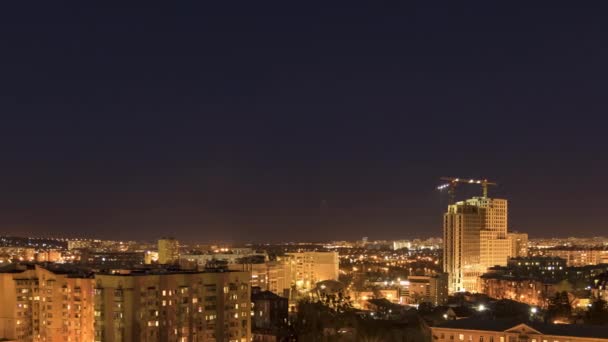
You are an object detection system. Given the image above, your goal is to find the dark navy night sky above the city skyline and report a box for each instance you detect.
[0,1,608,242]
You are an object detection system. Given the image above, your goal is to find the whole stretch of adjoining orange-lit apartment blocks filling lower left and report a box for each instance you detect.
[0,264,251,342]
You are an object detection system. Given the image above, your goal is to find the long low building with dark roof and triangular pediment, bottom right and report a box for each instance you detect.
[431,318,608,342]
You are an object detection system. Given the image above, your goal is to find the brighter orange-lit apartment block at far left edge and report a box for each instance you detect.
[0,264,96,342]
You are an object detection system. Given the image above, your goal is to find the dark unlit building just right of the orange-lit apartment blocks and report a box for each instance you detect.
[251,287,289,342]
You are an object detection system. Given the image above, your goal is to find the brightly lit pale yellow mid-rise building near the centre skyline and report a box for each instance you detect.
[287,252,339,289]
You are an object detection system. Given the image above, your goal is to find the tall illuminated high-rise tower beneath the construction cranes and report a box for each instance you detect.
[443,197,511,292]
